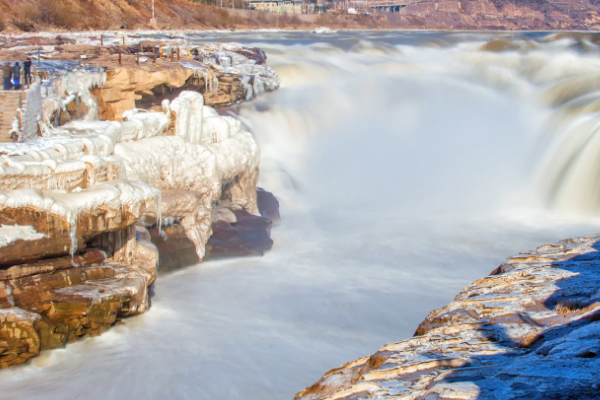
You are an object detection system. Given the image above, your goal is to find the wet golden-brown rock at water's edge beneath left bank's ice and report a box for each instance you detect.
[0,227,158,368]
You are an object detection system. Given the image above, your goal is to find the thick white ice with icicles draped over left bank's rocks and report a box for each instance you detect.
[0,92,259,258]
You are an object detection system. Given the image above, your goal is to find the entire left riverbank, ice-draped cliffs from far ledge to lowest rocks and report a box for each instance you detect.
[0,42,280,368]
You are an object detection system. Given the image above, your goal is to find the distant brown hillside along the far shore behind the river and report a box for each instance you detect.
[0,0,600,32]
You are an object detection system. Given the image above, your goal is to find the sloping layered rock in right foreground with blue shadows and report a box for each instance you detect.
[296,236,600,400]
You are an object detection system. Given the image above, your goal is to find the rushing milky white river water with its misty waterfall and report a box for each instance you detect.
[0,33,600,400]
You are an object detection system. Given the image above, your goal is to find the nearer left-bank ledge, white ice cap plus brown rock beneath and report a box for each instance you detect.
[0,78,276,368]
